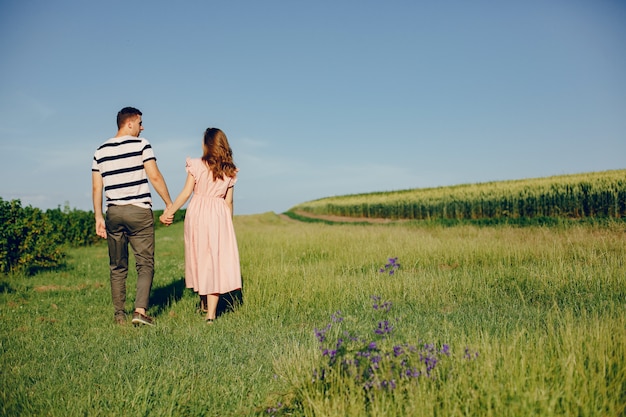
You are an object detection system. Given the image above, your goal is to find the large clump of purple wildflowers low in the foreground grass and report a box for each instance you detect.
[313,296,450,390]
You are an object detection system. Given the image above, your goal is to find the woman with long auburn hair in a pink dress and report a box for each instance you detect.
[160,128,241,324]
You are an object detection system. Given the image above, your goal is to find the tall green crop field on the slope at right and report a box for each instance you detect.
[292,170,626,220]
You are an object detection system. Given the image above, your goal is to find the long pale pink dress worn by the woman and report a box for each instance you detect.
[185,158,241,295]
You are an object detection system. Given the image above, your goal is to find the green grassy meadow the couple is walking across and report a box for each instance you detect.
[0,213,626,416]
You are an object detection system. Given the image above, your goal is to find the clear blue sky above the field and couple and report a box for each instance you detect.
[0,0,626,214]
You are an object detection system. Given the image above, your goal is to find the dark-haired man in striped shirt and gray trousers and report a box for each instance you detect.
[91,107,172,325]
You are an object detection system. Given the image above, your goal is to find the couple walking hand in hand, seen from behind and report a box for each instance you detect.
[91,107,241,325]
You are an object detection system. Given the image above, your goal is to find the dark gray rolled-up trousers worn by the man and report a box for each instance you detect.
[106,205,154,316]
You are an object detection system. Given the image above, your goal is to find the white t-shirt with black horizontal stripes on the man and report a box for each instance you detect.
[91,136,156,208]
